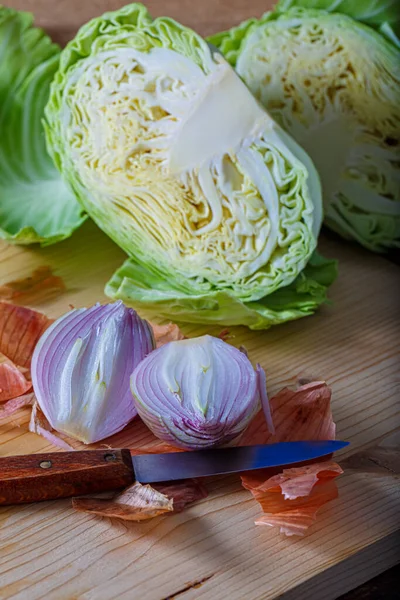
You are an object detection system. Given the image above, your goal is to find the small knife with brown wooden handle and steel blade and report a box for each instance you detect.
[0,441,348,505]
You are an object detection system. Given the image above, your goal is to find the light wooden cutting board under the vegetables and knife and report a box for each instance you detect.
[0,0,400,600]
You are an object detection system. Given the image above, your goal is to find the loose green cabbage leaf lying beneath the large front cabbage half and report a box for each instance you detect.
[106,252,337,329]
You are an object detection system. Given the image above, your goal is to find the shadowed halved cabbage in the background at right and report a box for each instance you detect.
[210,9,400,251]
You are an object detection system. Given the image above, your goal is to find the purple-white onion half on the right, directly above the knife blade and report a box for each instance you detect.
[131,335,268,450]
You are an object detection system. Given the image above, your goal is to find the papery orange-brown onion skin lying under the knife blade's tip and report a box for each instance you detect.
[241,381,343,535]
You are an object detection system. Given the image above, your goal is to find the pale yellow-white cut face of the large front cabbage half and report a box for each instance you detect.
[61,47,320,299]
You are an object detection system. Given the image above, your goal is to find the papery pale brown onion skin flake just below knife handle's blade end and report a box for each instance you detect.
[72,481,174,521]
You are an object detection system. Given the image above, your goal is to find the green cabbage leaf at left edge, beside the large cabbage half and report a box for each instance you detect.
[0,6,84,245]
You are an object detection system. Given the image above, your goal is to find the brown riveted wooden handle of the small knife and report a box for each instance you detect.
[0,450,135,505]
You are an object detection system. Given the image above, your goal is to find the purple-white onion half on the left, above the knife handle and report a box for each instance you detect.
[32,302,155,444]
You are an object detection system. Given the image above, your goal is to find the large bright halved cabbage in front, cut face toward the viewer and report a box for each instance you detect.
[46,4,334,323]
